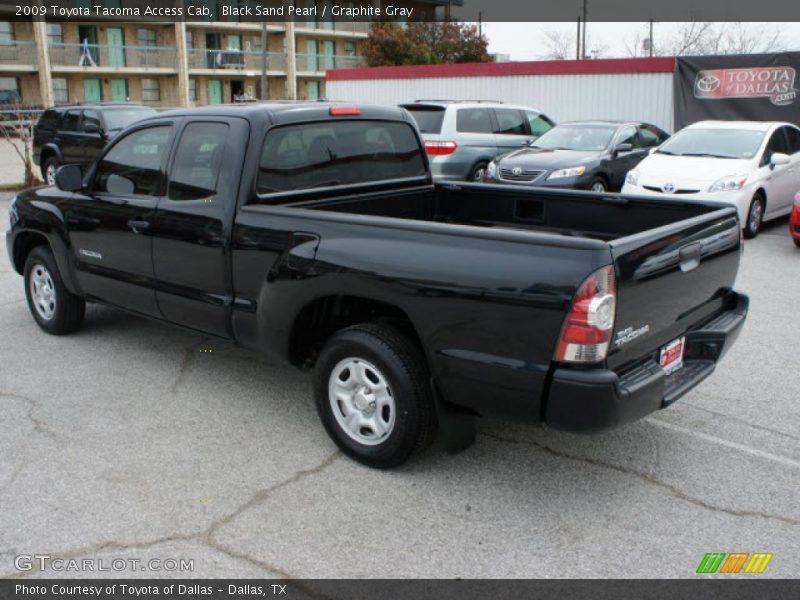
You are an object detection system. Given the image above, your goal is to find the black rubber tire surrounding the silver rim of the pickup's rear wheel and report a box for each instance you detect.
[314,323,436,469]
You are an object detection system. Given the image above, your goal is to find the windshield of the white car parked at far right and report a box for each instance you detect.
[657,128,764,158]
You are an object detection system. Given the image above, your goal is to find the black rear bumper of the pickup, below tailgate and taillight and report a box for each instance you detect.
[545,292,749,433]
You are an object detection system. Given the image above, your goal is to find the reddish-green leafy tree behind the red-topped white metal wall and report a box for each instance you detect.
[363,21,492,67]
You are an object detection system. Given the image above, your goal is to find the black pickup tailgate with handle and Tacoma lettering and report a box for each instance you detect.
[608,207,742,370]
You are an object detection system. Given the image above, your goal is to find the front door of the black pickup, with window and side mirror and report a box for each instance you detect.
[65,122,173,316]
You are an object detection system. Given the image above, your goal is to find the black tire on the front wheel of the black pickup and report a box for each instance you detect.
[24,246,86,335]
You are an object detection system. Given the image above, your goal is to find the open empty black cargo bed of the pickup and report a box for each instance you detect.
[292,183,719,241]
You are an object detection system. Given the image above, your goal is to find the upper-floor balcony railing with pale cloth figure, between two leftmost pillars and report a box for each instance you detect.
[50,44,178,69]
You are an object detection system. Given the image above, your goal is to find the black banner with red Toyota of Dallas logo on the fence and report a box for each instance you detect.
[674,52,800,131]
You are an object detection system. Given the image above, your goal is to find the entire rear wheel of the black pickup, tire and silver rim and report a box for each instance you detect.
[314,324,436,469]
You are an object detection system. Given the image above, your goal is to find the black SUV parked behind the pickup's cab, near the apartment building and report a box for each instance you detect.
[33,102,156,185]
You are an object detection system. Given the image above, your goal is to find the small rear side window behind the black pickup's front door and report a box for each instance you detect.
[167,123,229,200]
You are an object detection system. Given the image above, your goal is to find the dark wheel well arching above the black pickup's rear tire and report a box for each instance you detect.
[289,295,422,366]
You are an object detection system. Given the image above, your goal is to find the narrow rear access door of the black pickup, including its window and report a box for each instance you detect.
[153,117,249,337]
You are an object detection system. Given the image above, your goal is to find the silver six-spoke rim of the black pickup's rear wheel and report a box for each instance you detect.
[328,358,396,446]
